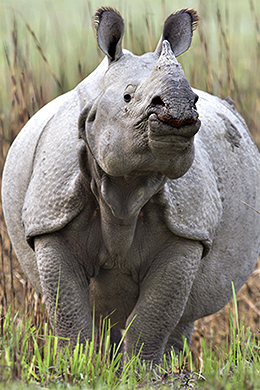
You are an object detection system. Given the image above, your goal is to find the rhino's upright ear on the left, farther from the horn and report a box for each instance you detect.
[94,7,124,61]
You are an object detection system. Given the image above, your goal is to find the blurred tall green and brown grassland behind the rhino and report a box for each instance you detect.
[0,0,260,372]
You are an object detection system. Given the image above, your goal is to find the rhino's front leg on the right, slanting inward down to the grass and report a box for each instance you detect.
[126,237,203,365]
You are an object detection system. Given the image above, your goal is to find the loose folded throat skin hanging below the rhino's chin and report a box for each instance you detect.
[96,173,164,256]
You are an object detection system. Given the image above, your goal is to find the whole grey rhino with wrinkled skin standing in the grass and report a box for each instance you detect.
[2,8,260,364]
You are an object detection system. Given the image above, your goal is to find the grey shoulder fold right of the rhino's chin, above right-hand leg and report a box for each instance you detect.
[162,137,223,255]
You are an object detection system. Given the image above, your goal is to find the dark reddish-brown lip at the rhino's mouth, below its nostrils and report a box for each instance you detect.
[148,108,201,138]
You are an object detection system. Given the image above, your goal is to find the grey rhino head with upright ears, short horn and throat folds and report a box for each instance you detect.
[79,8,200,254]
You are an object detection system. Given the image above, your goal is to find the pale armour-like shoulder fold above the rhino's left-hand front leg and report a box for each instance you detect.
[22,94,84,243]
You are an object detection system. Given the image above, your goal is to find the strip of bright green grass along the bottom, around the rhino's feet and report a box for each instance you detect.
[0,288,260,390]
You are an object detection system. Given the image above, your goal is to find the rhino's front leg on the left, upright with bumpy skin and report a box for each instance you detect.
[35,233,92,347]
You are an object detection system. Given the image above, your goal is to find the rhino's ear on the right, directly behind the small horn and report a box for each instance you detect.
[155,9,200,57]
